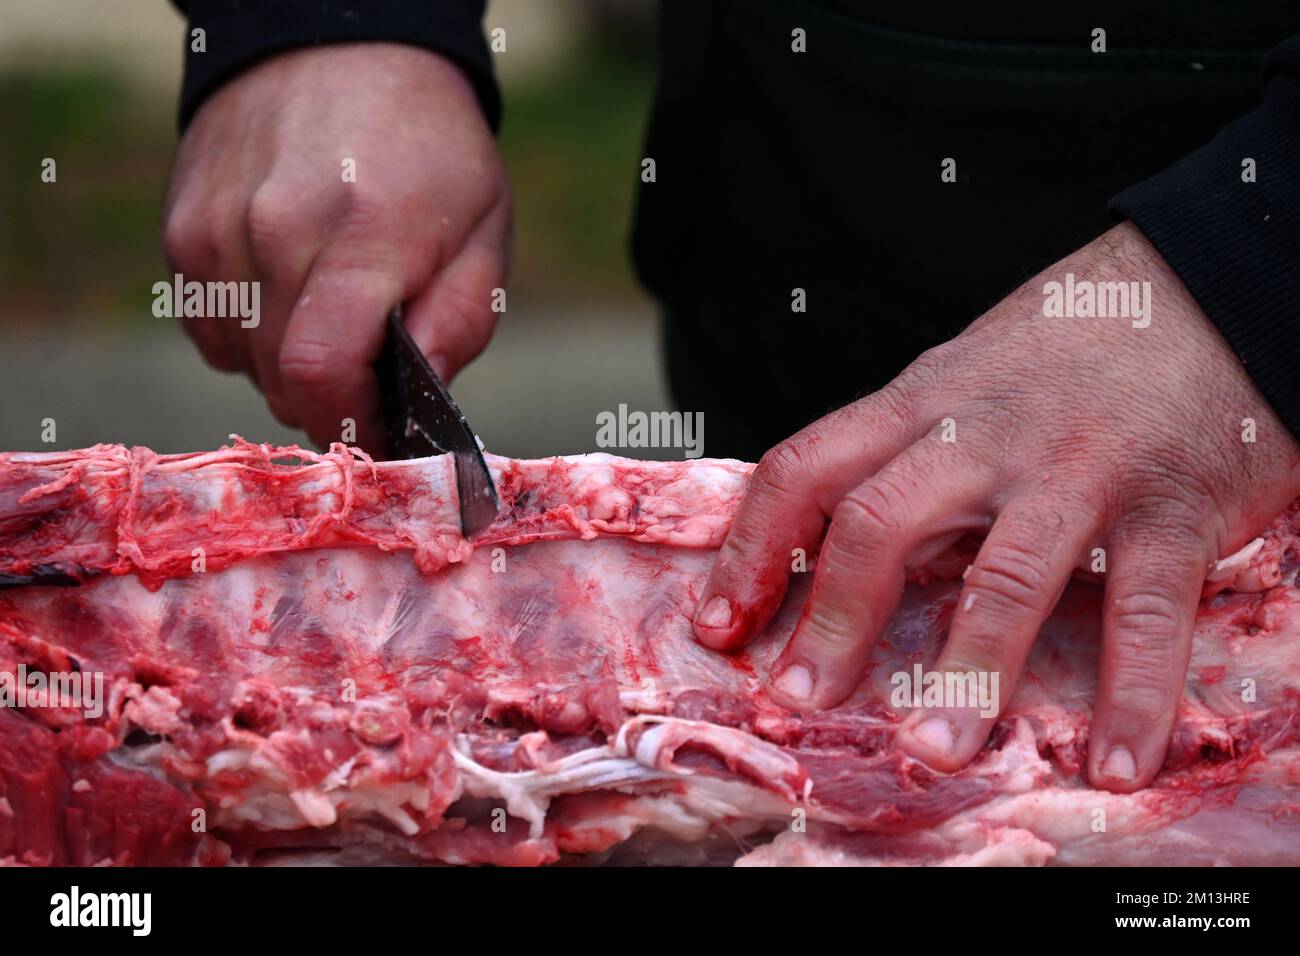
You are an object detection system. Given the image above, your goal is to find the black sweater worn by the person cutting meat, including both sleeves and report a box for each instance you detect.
[178,0,1300,458]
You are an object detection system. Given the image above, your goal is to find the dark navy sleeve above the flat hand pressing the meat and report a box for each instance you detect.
[1110,36,1300,438]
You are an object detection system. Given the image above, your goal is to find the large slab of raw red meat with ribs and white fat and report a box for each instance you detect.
[0,441,1300,865]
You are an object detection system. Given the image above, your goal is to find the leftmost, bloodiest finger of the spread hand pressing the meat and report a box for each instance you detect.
[694,389,923,650]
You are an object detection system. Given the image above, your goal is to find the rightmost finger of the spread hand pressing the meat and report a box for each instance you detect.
[1088,522,1209,793]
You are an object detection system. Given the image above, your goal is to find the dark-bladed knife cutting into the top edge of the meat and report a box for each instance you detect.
[374,307,498,537]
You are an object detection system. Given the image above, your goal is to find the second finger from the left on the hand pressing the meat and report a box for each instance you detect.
[770,441,993,710]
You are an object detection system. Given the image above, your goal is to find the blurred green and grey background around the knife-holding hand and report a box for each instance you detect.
[0,0,680,457]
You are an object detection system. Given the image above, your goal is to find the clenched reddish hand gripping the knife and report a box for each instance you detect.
[164,43,510,450]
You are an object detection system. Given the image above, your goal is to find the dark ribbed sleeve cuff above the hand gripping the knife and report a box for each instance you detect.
[174,0,501,131]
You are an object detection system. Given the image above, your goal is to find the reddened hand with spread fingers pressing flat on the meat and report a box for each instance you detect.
[696,224,1300,792]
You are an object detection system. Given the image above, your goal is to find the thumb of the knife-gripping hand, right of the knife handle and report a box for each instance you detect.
[406,193,510,382]
